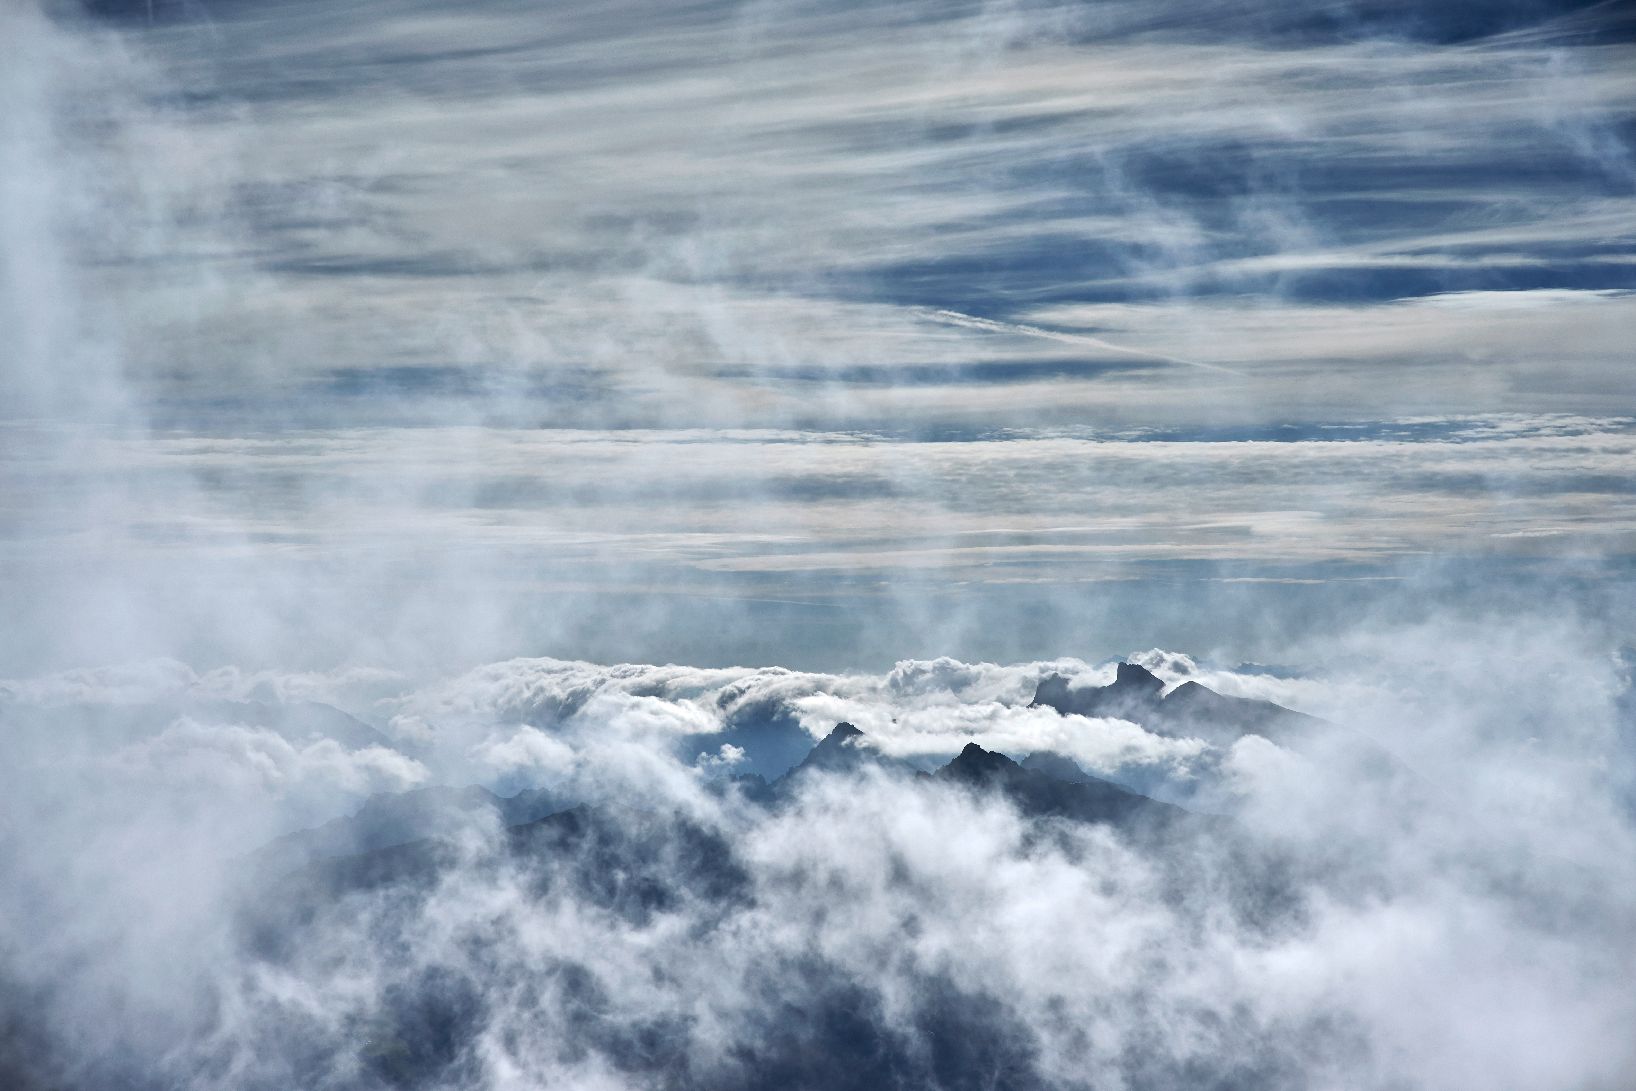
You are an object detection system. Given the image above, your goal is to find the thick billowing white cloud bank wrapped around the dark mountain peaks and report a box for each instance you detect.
[7,623,1636,1091]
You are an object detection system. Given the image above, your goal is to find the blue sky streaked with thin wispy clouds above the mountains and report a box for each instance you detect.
[0,0,1636,669]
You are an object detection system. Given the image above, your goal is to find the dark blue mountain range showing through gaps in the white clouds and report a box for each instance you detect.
[227,669,1328,1091]
